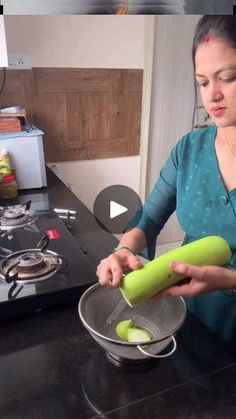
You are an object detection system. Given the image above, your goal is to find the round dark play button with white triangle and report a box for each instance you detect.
[93,185,142,234]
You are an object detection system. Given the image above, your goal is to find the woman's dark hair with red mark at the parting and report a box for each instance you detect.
[192,15,236,68]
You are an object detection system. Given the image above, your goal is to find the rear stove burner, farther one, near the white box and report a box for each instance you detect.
[0,201,37,230]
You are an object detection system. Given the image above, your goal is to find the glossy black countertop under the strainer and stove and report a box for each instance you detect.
[0,169,236,419]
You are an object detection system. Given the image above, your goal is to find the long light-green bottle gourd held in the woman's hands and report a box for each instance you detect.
[119,236,232,306]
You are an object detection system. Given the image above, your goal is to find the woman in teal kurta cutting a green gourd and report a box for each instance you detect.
[97,16,236,342]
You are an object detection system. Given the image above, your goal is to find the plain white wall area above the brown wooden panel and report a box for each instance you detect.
[5,15,145,68]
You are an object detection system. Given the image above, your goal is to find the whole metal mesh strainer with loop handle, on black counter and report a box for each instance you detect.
[78,284,186,362]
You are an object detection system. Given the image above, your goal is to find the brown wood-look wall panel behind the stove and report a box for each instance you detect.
[0,68,143,162]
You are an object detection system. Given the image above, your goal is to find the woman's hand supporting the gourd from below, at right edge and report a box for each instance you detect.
[155,262,236,298]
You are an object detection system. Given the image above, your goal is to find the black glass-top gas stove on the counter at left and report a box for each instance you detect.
[0,194,96,319]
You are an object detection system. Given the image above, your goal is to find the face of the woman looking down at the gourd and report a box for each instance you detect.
[195,36,236,127]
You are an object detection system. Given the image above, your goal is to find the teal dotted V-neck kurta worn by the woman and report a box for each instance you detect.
[136,125,236,343]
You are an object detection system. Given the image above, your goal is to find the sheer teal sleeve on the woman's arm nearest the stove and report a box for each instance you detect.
[132,144,179,259]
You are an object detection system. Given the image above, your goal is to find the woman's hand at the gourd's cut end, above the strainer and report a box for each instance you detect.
[96,250,143,288]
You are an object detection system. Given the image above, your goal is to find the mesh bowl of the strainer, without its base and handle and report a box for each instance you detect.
[79,284,186,351]
